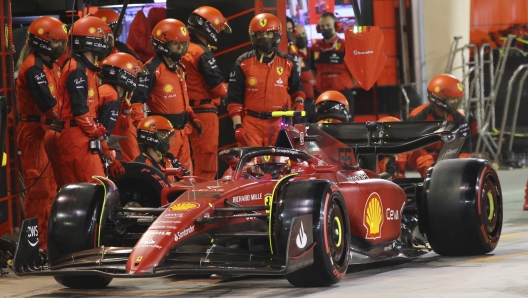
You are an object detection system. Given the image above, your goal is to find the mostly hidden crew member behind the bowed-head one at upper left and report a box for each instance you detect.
[93,9,139,161]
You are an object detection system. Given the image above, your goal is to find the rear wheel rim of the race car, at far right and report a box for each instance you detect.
[480,176,502,239]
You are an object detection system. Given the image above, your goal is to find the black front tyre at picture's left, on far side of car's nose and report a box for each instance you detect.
[48,183,112,289]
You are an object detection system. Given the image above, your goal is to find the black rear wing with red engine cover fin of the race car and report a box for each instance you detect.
[276,121,465,170]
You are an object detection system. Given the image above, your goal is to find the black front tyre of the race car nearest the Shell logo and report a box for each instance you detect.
[272,180,350,287]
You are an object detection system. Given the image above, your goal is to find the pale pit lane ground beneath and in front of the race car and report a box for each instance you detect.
[0,169,528,298]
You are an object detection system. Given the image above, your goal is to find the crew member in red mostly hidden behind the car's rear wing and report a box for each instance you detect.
[395,74,471,178]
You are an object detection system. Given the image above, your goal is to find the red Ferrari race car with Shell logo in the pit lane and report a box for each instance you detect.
[13,122,503,288]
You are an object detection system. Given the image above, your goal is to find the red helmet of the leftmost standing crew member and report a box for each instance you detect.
[27,16,68,60]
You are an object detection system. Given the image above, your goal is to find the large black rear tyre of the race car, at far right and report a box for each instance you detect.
[420,158,503,256]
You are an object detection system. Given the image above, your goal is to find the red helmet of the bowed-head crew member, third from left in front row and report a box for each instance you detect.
[100,52,144,92]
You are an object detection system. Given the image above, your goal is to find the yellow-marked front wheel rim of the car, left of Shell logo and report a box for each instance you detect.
[326,198,347,266]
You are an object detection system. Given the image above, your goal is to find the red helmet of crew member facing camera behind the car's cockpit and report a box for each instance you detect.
[249,13,282,54]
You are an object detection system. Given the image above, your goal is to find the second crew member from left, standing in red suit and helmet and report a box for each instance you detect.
[57,16,113,184]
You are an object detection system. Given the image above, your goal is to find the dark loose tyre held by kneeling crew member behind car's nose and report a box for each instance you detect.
[110,162,166,208]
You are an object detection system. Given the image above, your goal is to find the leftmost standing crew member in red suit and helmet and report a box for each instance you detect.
[16,16,68,250]
